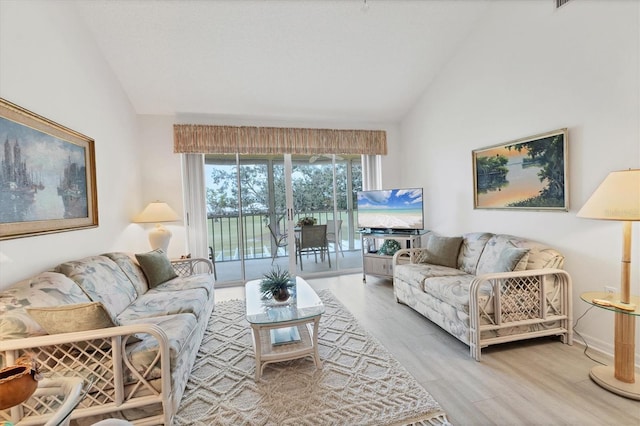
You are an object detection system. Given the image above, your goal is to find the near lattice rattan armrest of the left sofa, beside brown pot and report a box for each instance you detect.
[0,324,174,424]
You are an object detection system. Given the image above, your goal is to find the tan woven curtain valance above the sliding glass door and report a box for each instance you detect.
[173,124,387,155]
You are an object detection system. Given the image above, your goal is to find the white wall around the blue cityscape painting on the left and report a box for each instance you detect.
[0,0,146,288]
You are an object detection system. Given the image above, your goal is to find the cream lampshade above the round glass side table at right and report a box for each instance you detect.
[577,169,640,221]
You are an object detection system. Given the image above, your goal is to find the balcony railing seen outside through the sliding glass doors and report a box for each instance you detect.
[207,210,357,262]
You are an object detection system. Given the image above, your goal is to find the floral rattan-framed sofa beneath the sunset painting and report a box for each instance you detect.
[393,232,573,361]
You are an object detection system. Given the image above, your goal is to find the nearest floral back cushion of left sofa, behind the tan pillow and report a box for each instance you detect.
[0,272,91,341]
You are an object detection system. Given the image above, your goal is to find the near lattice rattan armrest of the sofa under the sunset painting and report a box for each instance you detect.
[469,268,573,361]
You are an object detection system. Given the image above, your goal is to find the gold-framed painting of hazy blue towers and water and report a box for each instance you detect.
[0,98,98,240]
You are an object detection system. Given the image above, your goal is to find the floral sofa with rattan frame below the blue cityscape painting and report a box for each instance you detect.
[0,250,214,425]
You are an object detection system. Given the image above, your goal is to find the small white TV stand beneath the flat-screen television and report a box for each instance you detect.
[360,229,426,283]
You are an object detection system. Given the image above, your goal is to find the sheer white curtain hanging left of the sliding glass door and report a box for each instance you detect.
[182,154,209,258]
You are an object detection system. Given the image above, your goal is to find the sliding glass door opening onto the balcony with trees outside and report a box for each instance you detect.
[205,155,362,282]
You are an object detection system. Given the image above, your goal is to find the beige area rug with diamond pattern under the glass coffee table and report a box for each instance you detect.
[175,290,448,425]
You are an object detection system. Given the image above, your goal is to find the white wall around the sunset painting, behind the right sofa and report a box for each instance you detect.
[401,0,640,359]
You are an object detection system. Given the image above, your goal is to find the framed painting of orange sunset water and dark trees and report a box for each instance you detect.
[473,129,569,211]
